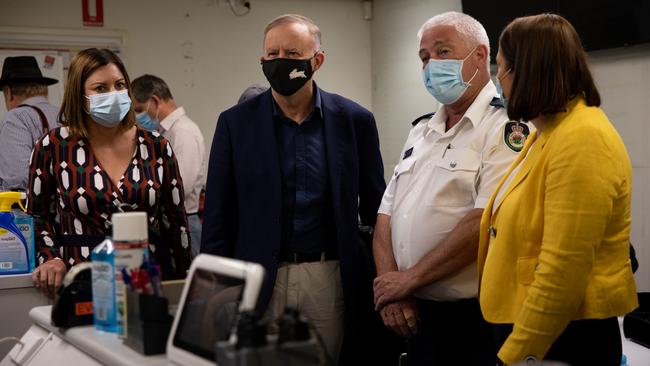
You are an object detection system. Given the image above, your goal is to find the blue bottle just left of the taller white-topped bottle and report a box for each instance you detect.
[91,238,117,333]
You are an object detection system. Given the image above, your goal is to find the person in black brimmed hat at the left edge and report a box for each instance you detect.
[0,56,59,191]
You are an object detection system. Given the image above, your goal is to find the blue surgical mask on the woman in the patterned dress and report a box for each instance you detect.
[86,90,131,128]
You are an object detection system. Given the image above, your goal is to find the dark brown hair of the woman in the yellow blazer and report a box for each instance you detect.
[499,14,600,121]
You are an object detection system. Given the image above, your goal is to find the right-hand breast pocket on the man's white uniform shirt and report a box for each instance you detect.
[430,148,480,206]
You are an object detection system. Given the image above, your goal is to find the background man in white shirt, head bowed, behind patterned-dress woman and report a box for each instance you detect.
[131,74,205,257]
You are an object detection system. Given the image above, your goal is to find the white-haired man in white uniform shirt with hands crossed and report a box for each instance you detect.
[373,12,528,366]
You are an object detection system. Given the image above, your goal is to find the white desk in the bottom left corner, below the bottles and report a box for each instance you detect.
[0,306,171,366]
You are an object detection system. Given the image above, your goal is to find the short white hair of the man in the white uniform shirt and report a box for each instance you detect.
[418,11,490,68]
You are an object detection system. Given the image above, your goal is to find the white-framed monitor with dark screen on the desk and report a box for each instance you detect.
[167,254,264,366]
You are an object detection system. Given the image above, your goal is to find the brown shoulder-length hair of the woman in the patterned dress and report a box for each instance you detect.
[59,48,135,138]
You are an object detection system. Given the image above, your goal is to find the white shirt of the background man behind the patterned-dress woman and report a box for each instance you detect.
[160,107,205,214]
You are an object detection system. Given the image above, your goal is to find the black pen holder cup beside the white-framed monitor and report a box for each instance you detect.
[124,290,173,355]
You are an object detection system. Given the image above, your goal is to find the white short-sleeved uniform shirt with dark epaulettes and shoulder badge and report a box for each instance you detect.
[379,81,517,301]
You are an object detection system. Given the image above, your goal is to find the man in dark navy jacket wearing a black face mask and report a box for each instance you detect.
[201,15,385,365]
